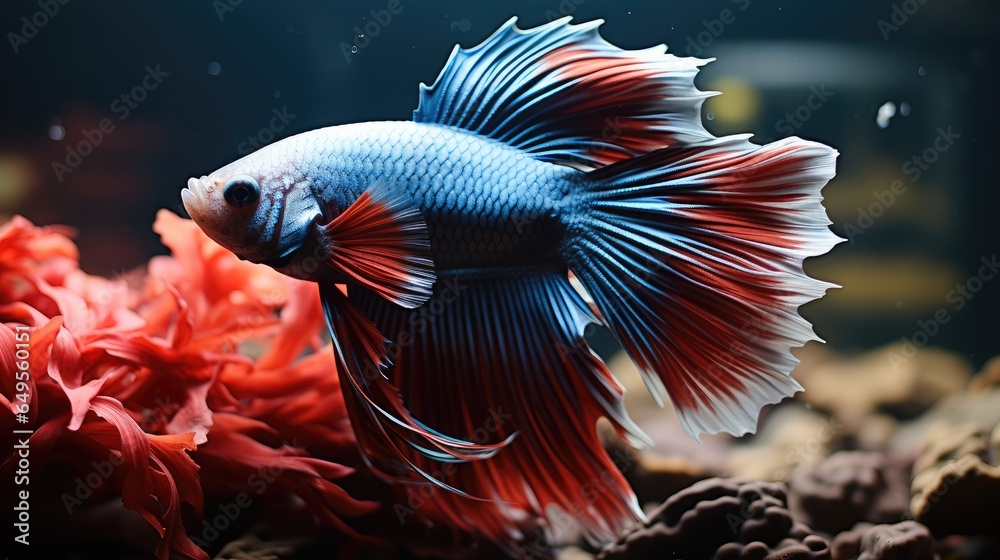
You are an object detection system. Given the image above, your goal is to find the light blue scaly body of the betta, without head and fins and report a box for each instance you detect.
[292,122,580,269]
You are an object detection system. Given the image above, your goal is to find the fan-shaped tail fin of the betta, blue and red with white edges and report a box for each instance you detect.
[566,136,841,439]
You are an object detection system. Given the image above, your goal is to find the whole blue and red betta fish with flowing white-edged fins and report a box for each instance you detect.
[181,18,841,543]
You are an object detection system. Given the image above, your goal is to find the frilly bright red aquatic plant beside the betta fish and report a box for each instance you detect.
[0,211,376,560]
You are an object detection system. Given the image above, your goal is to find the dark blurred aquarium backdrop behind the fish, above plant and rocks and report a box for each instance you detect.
[0,0,1000,367]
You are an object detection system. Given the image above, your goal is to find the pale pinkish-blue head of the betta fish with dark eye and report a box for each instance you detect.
[181,158,323,279]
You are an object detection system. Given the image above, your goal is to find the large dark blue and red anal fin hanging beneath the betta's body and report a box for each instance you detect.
[351,265,647,543]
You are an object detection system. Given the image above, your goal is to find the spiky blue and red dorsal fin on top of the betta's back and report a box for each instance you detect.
[413,17,714,168]
